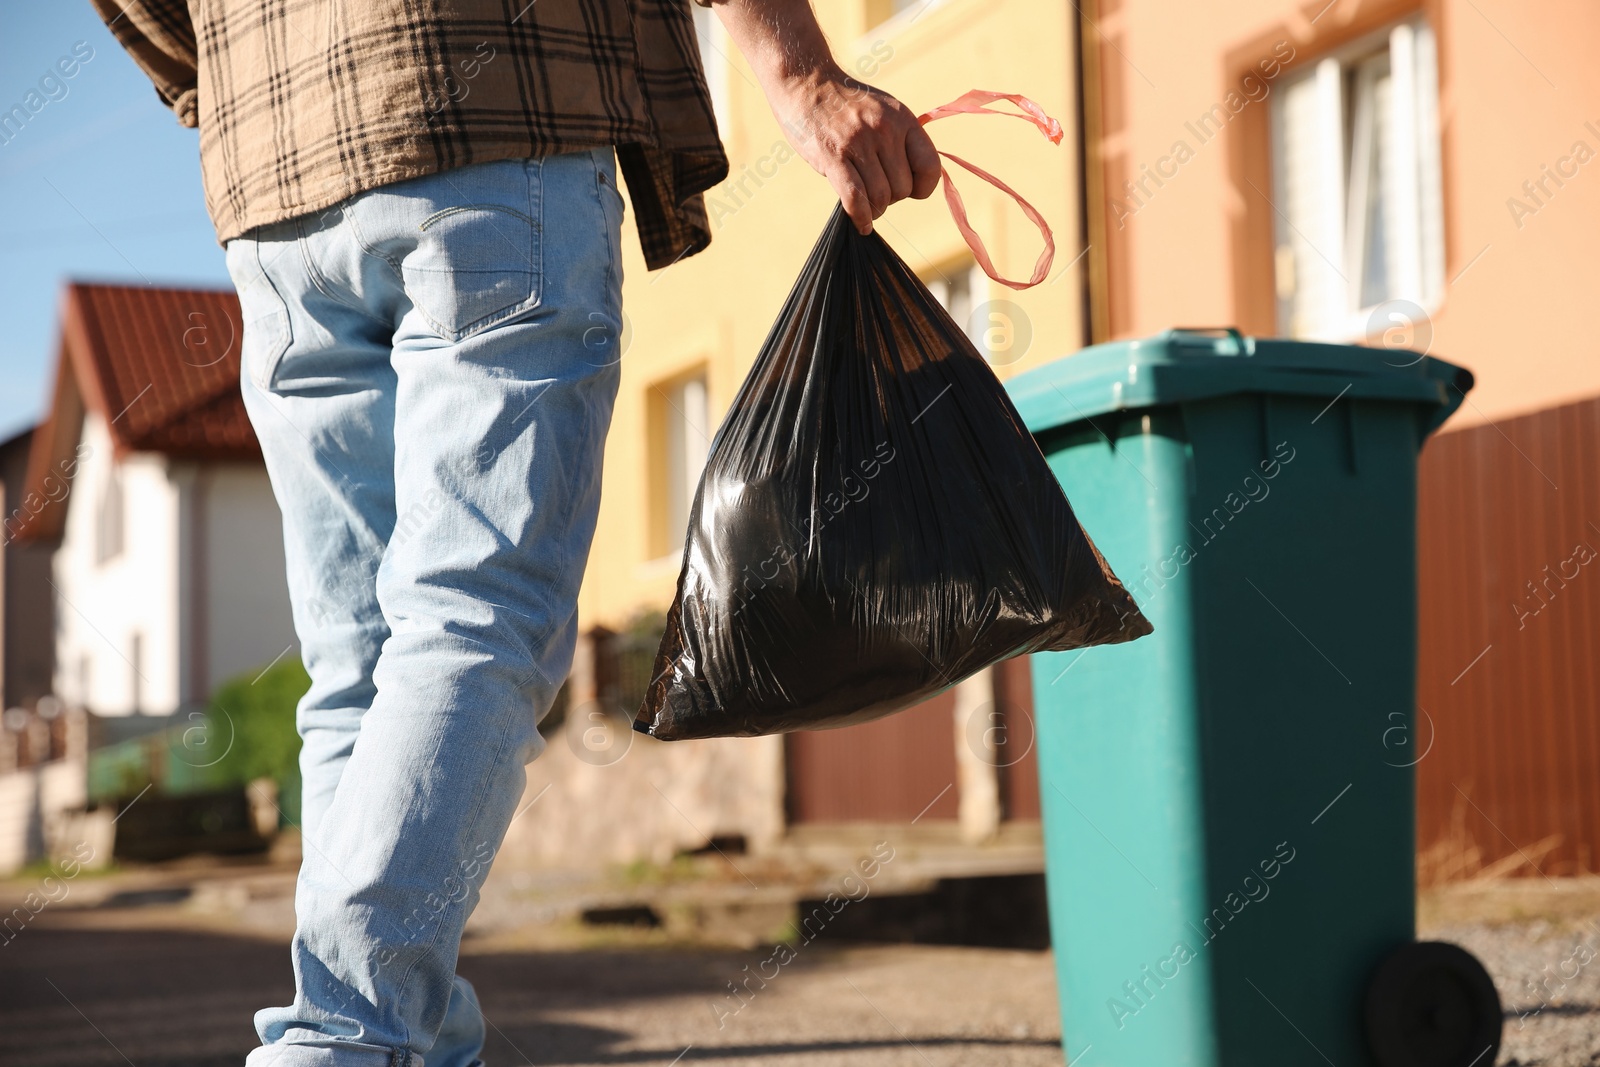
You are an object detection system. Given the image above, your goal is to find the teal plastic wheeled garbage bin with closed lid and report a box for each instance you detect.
[1008,330,1501,1067]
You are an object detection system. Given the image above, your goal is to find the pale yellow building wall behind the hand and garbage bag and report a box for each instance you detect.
[579,0,1082,627]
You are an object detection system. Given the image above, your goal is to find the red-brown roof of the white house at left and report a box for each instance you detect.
[6,283,261,539]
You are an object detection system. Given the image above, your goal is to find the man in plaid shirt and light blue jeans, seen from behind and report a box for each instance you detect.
[94,0,939,1067]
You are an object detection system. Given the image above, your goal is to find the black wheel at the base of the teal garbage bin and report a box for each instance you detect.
[1365,941,1502,1067]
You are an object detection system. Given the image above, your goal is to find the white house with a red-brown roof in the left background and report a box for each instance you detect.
[6,283,294,717]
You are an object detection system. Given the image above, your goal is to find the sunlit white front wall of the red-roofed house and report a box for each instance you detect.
[53,413,182,715]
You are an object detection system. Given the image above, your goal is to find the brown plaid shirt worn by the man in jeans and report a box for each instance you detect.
[93,0,728,269]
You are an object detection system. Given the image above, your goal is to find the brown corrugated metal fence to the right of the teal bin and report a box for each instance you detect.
[1397,391,1600,881]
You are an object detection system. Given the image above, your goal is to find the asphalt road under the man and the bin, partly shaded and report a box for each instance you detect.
[0,872,1600,1067]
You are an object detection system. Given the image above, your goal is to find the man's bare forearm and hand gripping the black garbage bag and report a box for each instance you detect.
[710,0,939,234]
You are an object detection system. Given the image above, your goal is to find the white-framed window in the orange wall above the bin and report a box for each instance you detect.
[1272,19,1445,339]
